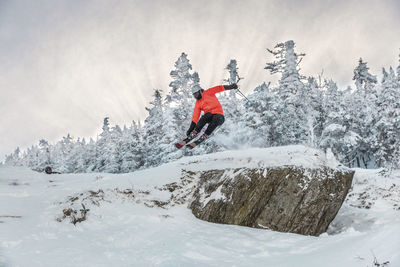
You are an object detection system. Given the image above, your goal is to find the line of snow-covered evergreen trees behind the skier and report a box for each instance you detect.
[5,40,400,173]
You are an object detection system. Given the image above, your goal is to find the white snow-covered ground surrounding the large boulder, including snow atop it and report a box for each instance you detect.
[0,146,400,267]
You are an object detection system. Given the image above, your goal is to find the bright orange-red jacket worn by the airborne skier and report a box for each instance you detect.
[192,85,225,123]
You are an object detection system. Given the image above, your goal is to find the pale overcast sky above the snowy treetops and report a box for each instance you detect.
[0,0,400,161]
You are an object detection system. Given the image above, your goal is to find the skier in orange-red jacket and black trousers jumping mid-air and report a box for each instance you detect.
[175,83,238,149]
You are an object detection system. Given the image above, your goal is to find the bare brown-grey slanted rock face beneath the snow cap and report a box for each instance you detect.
[190,166,354,236]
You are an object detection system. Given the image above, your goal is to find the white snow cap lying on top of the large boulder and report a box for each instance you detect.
[177,145,342,170]
